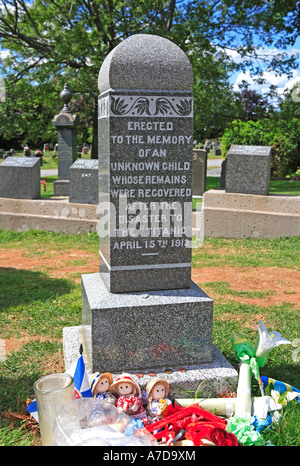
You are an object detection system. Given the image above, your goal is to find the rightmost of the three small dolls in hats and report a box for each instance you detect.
[146,379,172,421]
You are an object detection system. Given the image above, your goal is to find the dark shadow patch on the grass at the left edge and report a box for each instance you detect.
[0,267,74,312]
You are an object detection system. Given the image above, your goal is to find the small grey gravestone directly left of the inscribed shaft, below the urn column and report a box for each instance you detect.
[69,159,99,204]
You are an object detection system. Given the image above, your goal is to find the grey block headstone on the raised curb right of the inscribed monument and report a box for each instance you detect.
[225,145,272,195]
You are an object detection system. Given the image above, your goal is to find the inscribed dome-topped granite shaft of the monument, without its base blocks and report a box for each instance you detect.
[98,34,193,292]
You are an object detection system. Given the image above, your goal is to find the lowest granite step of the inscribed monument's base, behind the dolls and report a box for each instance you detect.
[63,326,238,398]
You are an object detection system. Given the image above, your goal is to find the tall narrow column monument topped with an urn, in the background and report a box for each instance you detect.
[52,84,78,196]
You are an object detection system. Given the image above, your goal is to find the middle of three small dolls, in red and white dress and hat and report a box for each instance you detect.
[110,373,146,419]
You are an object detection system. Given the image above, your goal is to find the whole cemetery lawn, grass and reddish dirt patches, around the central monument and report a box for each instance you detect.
[0,231,300,446]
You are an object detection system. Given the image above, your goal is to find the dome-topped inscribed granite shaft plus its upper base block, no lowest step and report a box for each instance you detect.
[82,34,213,372]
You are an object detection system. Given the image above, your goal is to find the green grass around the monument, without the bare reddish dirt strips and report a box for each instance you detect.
[0,231,300,446]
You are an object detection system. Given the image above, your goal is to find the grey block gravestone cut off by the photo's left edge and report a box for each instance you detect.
[0,157,41,199]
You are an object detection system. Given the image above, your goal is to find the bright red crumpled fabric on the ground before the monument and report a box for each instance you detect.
[146,404,238,446]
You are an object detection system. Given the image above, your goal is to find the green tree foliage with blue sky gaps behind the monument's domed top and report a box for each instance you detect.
[0,0,299,149]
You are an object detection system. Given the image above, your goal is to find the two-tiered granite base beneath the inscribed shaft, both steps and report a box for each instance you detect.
[63,273,238,398]
